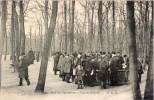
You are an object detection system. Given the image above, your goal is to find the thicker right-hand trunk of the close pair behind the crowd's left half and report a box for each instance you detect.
[70,0,75,53]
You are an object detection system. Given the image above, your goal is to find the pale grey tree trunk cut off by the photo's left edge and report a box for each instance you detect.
[0,0,7,88]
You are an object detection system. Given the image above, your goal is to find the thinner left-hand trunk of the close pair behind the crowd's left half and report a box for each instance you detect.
[64,0,67,52]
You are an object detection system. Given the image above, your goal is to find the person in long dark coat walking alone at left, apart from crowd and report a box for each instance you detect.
[18,53,30,86]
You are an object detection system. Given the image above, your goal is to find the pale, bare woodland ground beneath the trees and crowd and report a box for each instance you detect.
[0,57,146,100]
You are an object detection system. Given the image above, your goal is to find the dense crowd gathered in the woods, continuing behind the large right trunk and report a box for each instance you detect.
[53,52,143,89]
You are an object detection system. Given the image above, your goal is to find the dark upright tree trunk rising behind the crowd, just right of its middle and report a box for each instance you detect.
[98,1,103,50]
